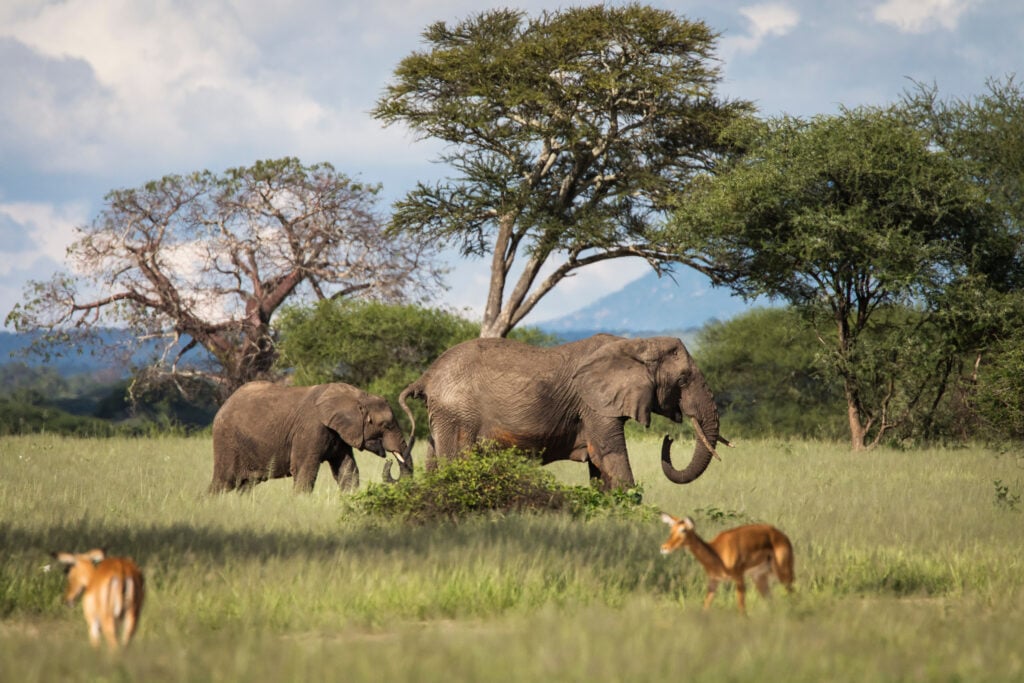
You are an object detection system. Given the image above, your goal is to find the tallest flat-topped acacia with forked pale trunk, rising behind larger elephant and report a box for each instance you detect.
[374,4,752,337]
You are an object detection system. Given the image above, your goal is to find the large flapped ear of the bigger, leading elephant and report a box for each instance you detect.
[572,339,658,427]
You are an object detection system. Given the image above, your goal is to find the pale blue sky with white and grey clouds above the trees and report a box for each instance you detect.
[0,0,1024,331]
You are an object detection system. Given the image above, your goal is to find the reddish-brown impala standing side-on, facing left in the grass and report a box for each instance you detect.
[662,512,793,614]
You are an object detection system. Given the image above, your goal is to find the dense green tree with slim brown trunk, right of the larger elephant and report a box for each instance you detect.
[674,108,1013,451]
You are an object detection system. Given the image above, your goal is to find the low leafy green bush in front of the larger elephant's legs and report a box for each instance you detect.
[348,443,656,522]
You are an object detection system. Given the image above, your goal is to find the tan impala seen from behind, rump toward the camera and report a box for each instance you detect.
[53,549,145,649]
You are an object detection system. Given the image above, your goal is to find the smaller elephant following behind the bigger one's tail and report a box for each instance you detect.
[210,382,413,493]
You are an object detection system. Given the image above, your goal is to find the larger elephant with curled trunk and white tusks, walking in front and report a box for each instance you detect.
[398,334,719,488]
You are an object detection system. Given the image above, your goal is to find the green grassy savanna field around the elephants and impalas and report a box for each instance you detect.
[0,435,1024,683]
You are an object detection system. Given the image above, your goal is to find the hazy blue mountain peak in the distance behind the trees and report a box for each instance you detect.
[537,267,767,339]
